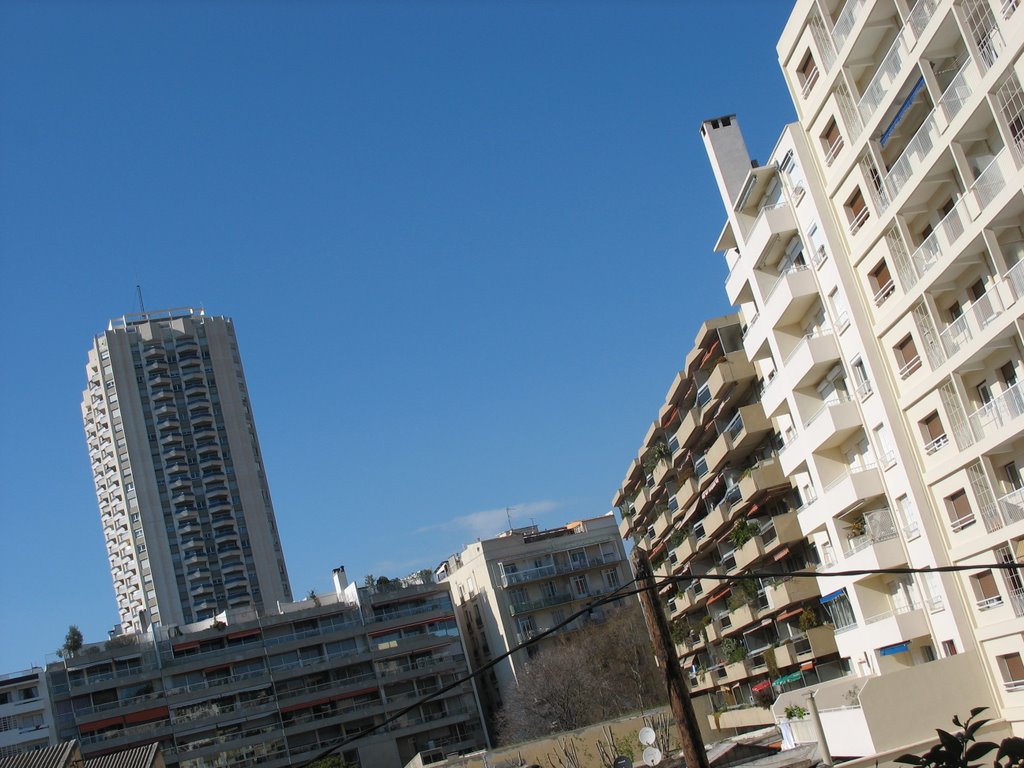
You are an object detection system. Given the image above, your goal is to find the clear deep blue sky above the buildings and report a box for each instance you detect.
[0,0,793,672]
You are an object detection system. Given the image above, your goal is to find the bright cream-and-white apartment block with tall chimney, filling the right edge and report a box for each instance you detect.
[663,0,1024,756]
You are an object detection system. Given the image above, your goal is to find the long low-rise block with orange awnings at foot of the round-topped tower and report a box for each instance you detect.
[46,569,486,768]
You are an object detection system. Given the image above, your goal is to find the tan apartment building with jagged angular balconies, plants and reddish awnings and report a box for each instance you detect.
[612,314,849,738]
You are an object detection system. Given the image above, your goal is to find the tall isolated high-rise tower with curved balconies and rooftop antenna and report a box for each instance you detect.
[82,308,292,631]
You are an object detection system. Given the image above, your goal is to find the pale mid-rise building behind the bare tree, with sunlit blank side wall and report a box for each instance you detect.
[434,512,632,741]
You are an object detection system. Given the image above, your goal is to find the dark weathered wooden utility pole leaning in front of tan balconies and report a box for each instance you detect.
[631,547,710,768]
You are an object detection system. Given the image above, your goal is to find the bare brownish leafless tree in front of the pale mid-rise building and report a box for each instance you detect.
[498,605,667,743]
